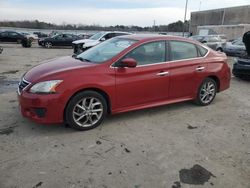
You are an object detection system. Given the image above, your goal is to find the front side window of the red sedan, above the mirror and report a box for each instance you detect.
[123,41,166,65]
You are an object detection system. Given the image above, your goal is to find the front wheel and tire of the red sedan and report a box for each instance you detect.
[65,91,107,131]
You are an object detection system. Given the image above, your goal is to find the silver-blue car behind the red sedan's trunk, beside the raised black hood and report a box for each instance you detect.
[223,38,246,57]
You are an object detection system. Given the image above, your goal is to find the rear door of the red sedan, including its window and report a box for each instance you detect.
[169,41,208,99]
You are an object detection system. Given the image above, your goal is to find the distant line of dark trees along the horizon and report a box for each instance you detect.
[0,20,189,32]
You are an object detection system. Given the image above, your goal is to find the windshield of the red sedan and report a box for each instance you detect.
[75,38,136,64]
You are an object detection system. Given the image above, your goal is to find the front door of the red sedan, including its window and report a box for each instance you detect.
[116,41,169,109]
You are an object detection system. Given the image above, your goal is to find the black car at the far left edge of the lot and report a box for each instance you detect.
[0,31,27,43]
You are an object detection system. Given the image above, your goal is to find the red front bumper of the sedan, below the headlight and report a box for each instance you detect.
[18,91,65,124]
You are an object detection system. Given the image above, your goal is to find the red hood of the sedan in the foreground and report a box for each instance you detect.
[24,56,95,83]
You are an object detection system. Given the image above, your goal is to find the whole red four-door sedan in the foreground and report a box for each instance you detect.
[18,35,231,130]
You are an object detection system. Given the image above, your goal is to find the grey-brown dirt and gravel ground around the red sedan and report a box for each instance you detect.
[0,44,250,188]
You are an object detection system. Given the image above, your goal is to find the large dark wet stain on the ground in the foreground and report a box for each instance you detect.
[179,164,216,185]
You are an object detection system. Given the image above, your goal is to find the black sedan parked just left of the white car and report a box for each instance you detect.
[38,34,79,48]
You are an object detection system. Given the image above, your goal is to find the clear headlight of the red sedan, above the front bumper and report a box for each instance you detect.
[30,80,63,93]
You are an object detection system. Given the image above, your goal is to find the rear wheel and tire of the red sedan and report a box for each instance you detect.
[195,78,218,106]
